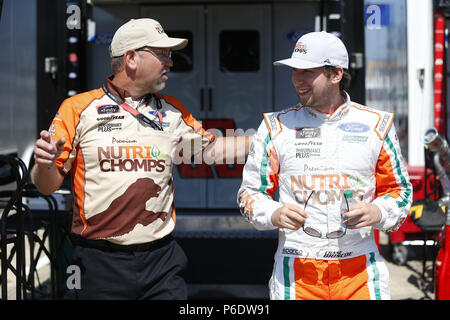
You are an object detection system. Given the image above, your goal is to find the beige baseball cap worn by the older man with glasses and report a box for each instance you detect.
[109,18,188,57]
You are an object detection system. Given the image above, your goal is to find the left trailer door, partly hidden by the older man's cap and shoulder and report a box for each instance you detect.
[141,5,208,208]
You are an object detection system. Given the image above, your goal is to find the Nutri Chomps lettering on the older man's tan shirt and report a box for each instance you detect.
[98,145,166,172]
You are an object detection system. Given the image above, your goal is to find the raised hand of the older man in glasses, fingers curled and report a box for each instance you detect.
[34,130,66,168]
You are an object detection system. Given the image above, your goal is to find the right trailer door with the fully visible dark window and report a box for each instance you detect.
[206,4,272,208]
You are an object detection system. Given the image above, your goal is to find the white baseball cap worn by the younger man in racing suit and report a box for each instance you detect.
[273,31,348,69]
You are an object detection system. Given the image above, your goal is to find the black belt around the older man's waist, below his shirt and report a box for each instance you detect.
[71,234,173,252]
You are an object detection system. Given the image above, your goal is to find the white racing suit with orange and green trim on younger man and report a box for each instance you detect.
[238,94,412,299]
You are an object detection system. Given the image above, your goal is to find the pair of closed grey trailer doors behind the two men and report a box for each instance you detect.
[141,5,272,209]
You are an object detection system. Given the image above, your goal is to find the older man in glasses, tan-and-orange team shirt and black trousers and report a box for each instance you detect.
[32,19,247,299]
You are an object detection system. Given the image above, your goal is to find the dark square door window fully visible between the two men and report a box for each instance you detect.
[220,30,259,72]
